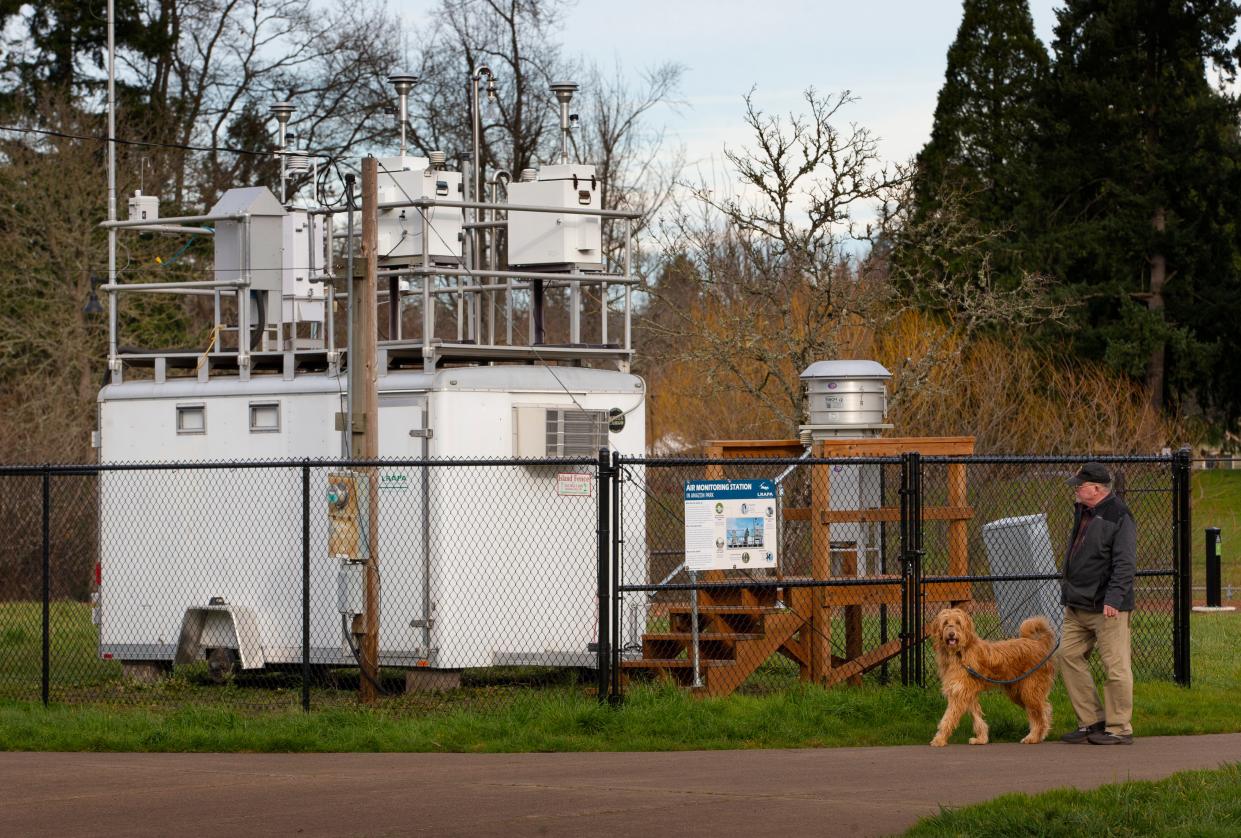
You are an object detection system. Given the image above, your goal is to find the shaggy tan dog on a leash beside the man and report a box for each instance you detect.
[931,608,1056,747]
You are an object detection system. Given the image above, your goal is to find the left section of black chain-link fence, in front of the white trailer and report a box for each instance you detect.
[0,459,598,709]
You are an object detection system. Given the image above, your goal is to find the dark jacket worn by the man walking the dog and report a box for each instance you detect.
[1060,494,1138,613]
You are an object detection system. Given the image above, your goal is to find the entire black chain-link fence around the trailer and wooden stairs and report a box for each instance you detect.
[0,454,1190,711]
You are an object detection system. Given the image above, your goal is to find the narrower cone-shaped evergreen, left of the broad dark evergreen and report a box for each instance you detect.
[897,0,1047,284]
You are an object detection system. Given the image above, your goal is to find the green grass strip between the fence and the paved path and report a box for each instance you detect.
[0,613,1241,752]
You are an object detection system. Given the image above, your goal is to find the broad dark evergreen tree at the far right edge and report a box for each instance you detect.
[1040,0,1241,418]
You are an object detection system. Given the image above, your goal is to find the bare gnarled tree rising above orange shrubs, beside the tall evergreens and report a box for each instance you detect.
[653,89,902,426]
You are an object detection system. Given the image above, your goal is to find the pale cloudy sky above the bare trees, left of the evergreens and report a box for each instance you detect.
[390,0,1060,171]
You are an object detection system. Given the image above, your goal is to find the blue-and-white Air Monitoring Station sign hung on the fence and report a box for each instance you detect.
[685,479,776,571]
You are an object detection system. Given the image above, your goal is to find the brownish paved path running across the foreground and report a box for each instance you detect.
[0,734,1241,838]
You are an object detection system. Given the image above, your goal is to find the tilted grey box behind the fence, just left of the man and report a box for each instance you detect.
[983,513,1065,637]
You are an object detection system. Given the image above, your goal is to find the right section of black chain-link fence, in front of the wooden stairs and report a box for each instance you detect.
[614,454,1189,695]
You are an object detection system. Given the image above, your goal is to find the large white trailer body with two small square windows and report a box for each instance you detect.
[97,366,645,669]
